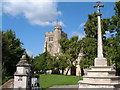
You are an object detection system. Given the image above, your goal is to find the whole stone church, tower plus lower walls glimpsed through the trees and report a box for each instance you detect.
[44,26,82,76]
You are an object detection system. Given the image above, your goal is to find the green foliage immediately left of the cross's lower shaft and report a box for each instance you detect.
[80,37,97,68]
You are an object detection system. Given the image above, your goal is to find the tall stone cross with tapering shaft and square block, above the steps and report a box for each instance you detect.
[93,1,107,66]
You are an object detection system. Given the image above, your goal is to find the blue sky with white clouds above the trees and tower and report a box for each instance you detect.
[2,0,115,56]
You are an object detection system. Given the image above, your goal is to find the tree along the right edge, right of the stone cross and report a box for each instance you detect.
[106,1,120,75]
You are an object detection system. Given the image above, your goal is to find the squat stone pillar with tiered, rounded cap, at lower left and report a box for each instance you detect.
[14,55,31,90]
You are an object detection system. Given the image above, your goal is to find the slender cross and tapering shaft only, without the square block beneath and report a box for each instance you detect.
[93,1,104,58]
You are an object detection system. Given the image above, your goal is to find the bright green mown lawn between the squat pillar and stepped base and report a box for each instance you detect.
[39,74,82,88]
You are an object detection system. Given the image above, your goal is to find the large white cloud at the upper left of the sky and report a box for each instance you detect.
[3,0,64,26]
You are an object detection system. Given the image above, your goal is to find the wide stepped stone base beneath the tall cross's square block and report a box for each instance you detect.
[79,63,120,90]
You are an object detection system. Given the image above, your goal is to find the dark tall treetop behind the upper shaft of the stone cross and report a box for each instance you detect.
[84,12,110,39]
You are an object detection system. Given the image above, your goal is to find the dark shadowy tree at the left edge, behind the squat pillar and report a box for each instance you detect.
[2,30,25,75]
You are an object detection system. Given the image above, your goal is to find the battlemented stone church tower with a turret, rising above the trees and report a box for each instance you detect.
[44,26,67,56]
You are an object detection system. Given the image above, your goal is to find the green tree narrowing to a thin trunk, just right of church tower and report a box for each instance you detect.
[59,36,80,75]
